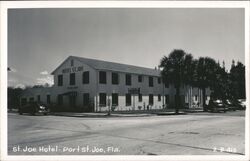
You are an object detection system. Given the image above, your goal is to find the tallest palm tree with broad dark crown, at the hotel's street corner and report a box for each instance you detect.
[159,49,194,114]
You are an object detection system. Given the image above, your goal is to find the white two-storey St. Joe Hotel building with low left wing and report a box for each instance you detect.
[20,56,211,112]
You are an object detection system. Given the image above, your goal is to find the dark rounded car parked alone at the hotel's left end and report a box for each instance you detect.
[18,102,50,115]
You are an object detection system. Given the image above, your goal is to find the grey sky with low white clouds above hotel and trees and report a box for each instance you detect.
[8,8,245,87]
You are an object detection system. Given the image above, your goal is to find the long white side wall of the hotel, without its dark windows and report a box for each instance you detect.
[95,71,168,111]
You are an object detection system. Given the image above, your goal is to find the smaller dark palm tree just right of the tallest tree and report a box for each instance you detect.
[195,57,217,110]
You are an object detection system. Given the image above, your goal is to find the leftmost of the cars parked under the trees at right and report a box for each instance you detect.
[206,99,228,112]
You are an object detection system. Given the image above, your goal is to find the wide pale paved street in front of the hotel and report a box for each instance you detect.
[8,111,245,155]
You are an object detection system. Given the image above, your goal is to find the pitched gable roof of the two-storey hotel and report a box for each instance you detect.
[52,56,160,76]
